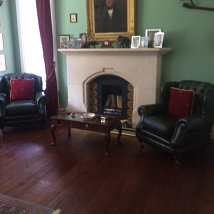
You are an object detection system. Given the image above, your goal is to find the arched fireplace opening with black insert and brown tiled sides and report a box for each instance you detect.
[90,75,133,126]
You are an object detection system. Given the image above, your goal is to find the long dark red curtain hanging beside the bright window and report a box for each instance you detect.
[36,0,58,116]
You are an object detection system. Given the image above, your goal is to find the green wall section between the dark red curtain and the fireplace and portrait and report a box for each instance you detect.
[55,0,86,107]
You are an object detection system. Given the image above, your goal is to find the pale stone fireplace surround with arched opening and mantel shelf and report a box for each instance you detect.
[58,48,171,127]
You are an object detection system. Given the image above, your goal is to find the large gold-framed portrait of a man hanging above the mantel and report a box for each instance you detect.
[86,0,135,41]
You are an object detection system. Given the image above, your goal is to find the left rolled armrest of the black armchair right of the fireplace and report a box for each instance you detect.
[138,104,167,117]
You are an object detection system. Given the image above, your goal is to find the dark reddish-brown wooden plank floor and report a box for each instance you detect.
[0,127,214,214]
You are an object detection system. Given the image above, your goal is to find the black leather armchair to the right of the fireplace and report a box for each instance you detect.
[136,80,214,163]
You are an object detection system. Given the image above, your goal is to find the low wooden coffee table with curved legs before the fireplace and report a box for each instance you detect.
[50,113,122,155]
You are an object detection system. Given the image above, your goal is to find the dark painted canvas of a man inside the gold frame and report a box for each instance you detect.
[94,0,127,33]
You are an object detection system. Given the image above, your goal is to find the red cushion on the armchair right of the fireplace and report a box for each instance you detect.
[168,87,194,117]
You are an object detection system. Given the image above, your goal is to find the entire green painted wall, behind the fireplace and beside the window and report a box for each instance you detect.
[0,0,214,107]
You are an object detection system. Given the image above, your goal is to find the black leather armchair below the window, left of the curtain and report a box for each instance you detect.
[0,73,48,129]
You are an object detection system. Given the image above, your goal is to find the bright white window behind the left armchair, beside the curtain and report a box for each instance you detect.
[16,0,46,89]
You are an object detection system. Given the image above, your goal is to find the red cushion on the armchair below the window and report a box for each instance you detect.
[10,79,34,101]
